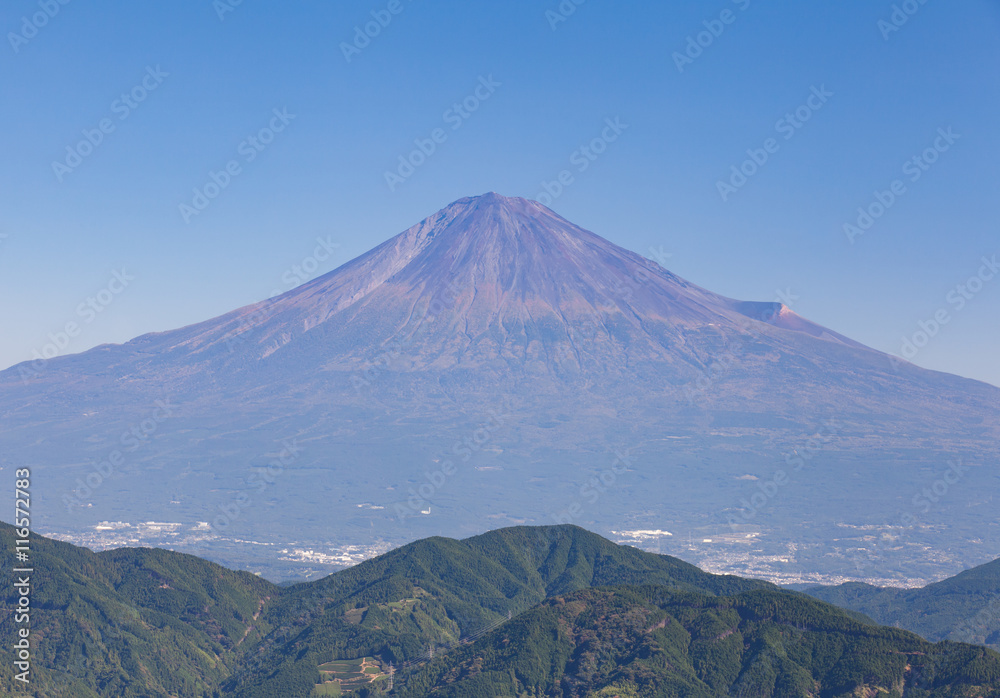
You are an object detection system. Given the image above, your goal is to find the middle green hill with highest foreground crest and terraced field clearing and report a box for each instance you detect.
[225,525,773,698]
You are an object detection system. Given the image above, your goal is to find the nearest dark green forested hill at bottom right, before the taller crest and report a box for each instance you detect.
[398,586,1000,698]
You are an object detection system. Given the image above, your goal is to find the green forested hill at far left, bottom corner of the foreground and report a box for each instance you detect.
[0,523,280,698]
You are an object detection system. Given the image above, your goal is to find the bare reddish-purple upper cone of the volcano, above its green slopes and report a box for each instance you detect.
[94,192,868,372]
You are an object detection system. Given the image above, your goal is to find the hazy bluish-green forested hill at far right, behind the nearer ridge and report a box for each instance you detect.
[804,560,1000,650]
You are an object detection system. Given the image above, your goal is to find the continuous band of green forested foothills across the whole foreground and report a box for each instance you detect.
[0,524,1000,698]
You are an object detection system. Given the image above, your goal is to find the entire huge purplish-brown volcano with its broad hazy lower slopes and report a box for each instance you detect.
[0,193,1000,580]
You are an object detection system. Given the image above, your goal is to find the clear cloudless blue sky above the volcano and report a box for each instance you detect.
[0,0,1000,385]
